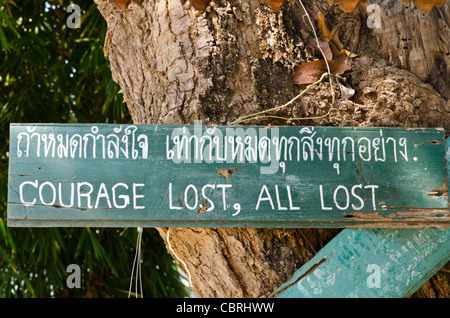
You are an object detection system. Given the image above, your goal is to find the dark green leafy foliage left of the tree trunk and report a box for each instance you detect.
[0,0,187,298]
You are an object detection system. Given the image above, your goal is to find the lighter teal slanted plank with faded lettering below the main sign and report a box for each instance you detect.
[275,139,450,298]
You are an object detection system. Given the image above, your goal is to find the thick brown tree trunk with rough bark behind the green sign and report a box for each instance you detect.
[95,0,450,297]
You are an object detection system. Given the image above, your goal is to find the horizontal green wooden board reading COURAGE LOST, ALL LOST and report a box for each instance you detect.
[8,124,449,228]
